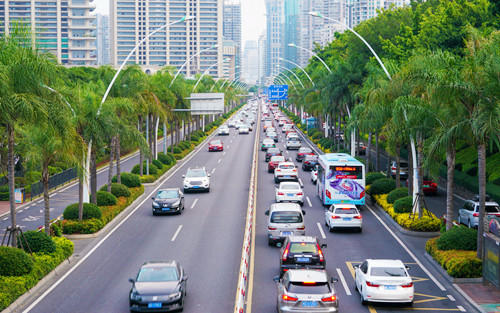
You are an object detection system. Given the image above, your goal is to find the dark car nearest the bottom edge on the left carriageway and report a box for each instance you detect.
[129,261,187,312]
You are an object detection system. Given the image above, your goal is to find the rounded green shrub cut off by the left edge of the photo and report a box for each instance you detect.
[0,246,33,276]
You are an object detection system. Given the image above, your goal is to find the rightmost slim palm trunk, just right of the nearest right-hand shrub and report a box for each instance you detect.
[477,143,486,260]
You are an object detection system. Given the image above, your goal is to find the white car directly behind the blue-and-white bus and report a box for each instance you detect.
[325,203,363,232]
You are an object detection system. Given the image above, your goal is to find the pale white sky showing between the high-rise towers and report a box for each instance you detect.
[94,0,266,47]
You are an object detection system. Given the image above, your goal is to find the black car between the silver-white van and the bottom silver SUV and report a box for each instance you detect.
[280,236,326,276]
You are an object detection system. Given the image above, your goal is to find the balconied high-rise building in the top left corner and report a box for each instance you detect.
[0,0,97,66]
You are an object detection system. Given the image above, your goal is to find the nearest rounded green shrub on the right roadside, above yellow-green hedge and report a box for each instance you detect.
[437,227,477,251]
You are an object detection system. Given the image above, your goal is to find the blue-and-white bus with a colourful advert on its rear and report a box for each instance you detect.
[316,153,365,206]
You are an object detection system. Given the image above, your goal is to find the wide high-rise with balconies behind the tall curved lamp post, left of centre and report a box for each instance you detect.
[110,0,223,77]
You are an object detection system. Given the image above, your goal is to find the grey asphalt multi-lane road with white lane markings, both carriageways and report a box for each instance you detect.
[7,100,476,313]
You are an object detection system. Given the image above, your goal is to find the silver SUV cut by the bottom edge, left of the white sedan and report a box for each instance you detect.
[274,269,339,313]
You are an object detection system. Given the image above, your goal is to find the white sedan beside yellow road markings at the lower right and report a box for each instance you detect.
[354,259,414,305]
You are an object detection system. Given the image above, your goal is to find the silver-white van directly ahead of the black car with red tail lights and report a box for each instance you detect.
[266,203,306,245]
